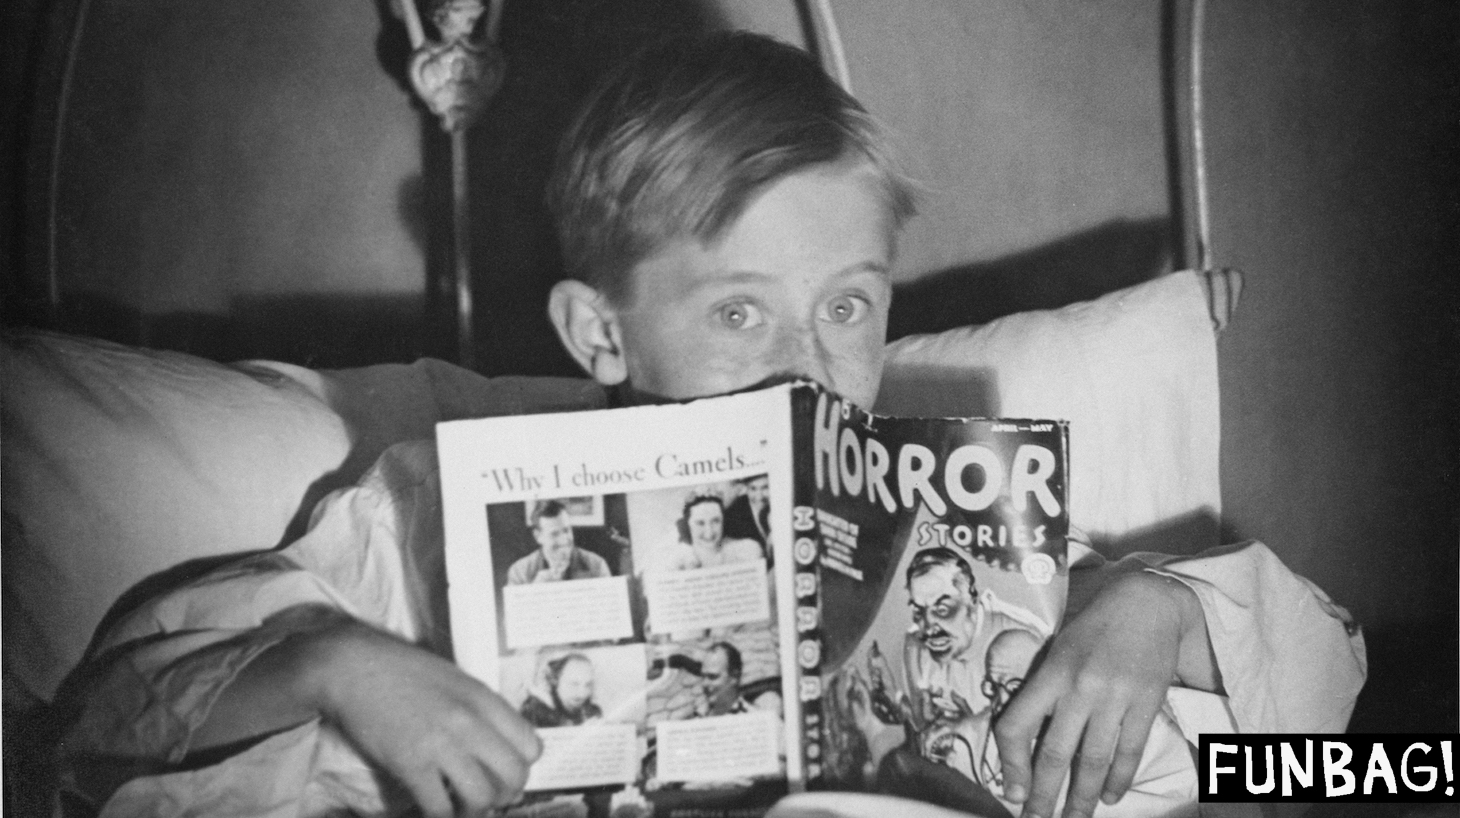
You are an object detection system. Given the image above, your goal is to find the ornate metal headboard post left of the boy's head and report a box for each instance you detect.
[399,0,507,368]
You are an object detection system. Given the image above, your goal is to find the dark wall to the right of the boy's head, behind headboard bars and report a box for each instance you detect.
[841,0,1460,744]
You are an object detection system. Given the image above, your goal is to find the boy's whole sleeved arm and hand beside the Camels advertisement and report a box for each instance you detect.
[63,443,537,814]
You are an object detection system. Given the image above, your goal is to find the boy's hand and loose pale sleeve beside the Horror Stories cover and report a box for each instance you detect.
[996,542,1365,817]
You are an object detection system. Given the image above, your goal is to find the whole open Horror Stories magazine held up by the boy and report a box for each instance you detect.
[437,383,1069,817]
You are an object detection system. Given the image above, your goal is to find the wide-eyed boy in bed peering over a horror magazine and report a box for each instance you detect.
[56,35,1356,817]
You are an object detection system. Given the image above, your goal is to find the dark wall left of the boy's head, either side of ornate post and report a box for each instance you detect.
[3,0,802,374]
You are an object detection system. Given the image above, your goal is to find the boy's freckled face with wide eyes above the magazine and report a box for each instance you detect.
[615,162,894,408]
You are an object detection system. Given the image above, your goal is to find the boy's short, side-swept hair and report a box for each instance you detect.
[548,32,914,305]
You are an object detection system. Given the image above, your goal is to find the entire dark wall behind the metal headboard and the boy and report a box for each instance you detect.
[0,0,1460,747]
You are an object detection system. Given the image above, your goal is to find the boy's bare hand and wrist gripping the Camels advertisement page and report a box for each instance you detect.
[191,618,542,817]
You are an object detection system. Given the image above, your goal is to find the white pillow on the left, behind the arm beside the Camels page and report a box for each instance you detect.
[0,332,603,700]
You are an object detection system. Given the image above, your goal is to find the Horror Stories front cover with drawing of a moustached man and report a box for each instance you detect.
[794,387,1069,815]
